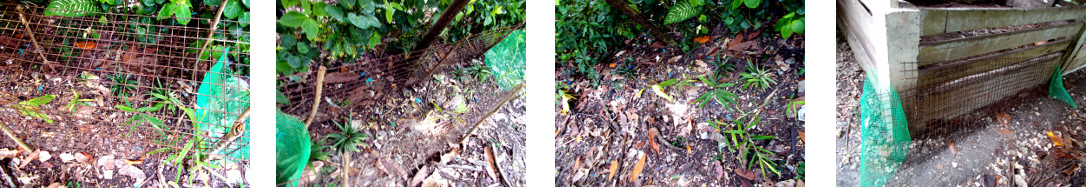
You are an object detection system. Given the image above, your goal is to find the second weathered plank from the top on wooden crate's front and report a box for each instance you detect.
[917,23,1083,63]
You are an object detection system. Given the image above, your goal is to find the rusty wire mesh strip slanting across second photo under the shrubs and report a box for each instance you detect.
[277,23,523,117]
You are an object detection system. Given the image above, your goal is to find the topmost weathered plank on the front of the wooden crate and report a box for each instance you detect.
[921,7,1086,35]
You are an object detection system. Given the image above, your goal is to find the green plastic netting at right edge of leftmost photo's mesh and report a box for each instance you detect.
[195,48,249,159]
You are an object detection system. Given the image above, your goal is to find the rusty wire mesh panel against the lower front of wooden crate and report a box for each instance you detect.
[902,54,1063,134]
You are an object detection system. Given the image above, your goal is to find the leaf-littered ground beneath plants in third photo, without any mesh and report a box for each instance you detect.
[554,27,806,187]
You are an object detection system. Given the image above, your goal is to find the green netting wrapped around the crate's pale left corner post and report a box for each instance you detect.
[860,74,912,187]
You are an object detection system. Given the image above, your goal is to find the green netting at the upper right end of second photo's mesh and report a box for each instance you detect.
[483,29,527,90]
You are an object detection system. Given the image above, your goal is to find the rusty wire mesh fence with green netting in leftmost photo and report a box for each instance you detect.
[0,3,250,160]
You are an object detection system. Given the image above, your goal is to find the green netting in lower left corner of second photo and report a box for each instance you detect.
[275,111,311,186]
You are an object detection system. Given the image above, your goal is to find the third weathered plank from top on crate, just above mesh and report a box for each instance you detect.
[918,39,1072,87]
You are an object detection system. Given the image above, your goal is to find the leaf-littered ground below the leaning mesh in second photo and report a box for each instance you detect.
[288,57,527,187]
